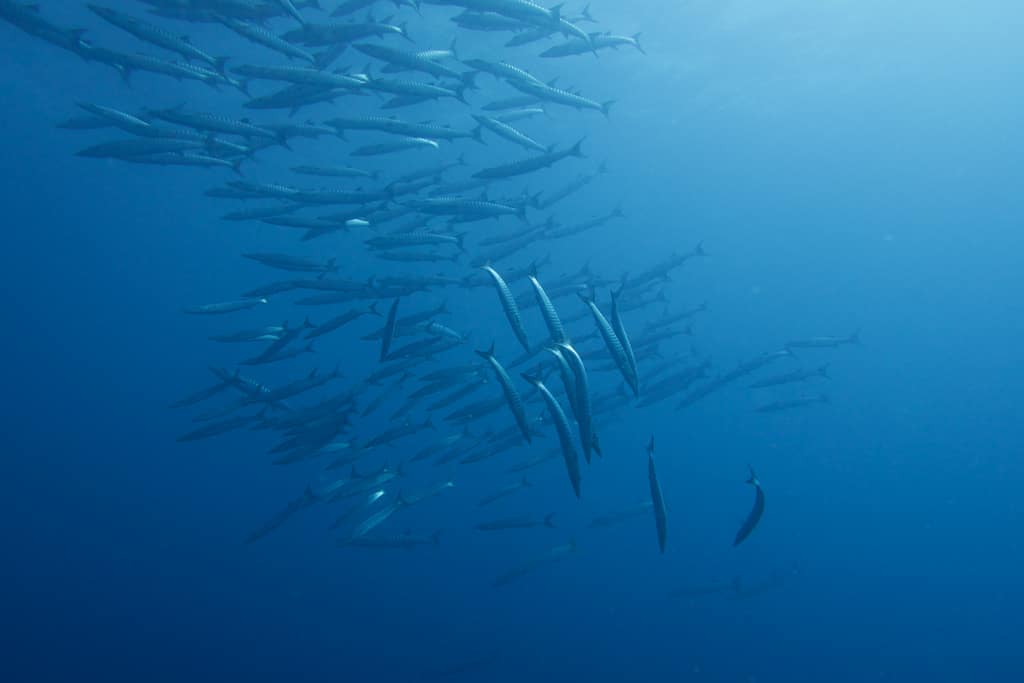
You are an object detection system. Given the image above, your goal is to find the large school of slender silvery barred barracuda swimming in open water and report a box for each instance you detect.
[0,0,859,587]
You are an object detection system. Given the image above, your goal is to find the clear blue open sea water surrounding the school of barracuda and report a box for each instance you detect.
[0,0,1024,683]
